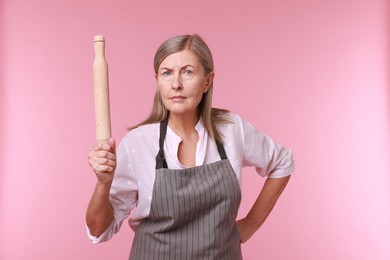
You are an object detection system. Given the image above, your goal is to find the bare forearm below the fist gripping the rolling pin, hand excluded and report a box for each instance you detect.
[86,182,114,237]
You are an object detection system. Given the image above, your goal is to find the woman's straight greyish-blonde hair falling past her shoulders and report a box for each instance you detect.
[129,34,230,143]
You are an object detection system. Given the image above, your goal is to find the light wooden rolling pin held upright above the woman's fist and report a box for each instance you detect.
[93,35,111,143]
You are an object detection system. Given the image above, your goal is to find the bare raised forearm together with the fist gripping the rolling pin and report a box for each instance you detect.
[86,138,116,237]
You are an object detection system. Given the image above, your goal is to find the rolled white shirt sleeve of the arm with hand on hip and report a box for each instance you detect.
[240,116,294,178]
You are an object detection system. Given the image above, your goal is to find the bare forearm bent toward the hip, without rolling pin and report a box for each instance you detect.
[237,176,290,243]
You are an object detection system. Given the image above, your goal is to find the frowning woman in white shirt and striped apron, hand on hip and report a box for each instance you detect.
[86,35,294,259]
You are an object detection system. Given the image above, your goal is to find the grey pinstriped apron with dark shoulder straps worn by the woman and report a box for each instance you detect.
[129,121,242,260]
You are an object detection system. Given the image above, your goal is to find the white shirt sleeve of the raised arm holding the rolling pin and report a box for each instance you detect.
[87,138,138,244]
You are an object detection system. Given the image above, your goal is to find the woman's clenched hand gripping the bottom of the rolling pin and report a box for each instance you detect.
[88,138,116,184]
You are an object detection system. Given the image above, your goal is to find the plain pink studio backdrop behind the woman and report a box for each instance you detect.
[0,0,390,260]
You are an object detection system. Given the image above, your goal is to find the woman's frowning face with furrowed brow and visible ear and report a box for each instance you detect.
[156,50,213,119]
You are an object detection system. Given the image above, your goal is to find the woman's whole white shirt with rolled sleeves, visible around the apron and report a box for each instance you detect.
[87,113,294,244]
